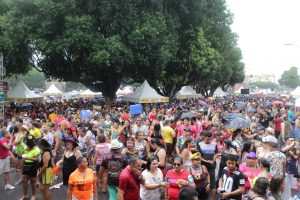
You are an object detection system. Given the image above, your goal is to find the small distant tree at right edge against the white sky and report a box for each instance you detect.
[278,67,300,89]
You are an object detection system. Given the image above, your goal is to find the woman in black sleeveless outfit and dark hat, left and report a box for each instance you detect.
[56,137,82,185]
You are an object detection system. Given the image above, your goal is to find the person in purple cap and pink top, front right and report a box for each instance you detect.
[240,152,260,193]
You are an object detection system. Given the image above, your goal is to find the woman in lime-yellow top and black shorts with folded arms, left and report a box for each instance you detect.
[20,135,41,200]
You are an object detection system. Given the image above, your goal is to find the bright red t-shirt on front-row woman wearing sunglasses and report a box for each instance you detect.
[166,170,189,200]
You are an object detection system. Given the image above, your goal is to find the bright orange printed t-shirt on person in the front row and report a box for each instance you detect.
[69,168,94,200]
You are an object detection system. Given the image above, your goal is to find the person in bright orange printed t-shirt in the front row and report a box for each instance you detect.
[67,157,98,200]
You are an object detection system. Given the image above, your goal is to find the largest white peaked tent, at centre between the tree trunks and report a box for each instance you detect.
[122,80,169,103]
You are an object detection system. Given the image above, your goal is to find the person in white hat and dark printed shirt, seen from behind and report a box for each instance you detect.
[98,139,128,200]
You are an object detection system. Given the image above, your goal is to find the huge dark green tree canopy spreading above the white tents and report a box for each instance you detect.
[0,0,244,98]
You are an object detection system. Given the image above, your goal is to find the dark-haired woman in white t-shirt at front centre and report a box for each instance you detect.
[140,156,168,200]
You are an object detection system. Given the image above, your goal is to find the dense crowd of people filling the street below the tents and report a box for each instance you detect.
[0,96,300,200]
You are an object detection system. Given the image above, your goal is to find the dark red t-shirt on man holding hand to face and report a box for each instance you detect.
[119,166,140,200]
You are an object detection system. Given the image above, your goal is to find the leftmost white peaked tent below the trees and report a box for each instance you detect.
[7,80,43,102]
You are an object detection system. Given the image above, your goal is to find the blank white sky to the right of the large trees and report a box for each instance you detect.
[226,0,300,79]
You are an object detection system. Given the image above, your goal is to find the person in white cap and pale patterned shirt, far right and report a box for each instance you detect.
[262,135,286,177]
